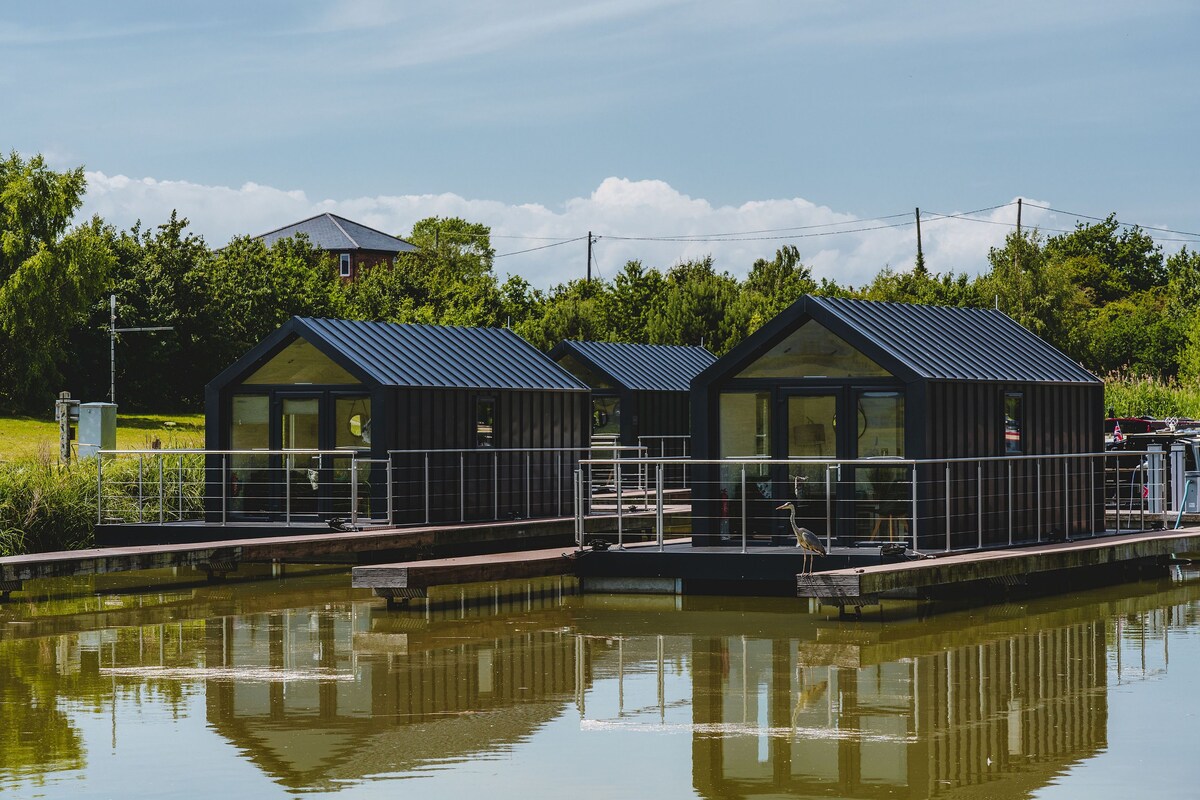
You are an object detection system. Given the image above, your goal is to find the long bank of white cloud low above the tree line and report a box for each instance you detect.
[83,172,1062,288]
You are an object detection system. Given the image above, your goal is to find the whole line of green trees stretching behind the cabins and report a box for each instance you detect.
[0,152,1200,415]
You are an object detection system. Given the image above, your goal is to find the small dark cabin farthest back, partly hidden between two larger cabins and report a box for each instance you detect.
[550,341,716,456]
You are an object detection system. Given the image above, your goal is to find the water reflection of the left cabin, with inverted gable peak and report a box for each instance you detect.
[205,597,580,789]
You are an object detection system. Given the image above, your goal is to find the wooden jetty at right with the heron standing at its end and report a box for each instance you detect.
[796,528,1200,607]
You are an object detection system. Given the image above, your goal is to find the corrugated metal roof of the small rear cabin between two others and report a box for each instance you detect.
[551,341,716,391]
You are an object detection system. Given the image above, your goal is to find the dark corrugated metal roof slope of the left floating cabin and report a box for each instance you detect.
[294,317,587,391]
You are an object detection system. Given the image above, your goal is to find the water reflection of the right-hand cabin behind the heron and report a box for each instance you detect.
[692,614,1108,798]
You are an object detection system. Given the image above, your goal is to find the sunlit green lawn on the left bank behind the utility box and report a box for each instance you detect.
[0,414,204,461]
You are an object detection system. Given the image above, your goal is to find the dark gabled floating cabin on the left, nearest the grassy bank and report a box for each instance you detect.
[205,317,589,523]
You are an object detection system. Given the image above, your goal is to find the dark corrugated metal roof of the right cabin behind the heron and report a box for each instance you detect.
[805,296,1097,383]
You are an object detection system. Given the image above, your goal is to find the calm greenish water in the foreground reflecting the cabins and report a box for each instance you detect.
[0,572,1200,800]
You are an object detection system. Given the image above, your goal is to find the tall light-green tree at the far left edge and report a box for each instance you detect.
[0,152,113,410]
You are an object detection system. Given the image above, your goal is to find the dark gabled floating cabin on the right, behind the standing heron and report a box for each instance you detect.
[691,296,1104,549]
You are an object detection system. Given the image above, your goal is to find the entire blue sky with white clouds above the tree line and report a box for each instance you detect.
[0,0,1200,288]
